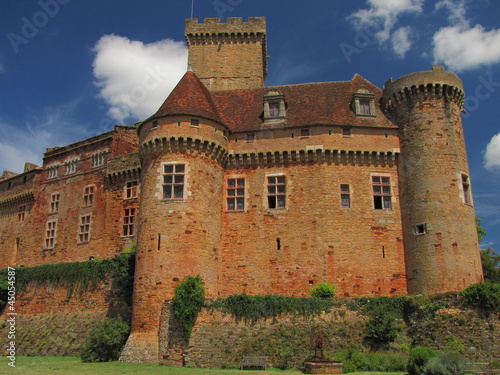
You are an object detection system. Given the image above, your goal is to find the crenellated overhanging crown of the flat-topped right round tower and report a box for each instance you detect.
[382,65,465,110]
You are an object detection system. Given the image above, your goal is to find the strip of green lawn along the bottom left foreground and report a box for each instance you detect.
[0,356,403,375]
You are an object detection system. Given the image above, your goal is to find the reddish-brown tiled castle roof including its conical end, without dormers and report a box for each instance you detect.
[152,71,395,132]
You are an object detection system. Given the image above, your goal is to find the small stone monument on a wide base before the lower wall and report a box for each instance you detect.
[302,327,342,374]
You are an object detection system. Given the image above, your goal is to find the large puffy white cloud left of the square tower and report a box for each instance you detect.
[94,35,187,122]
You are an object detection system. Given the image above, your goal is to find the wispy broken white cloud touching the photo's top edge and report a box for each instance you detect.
[349,0,424,57]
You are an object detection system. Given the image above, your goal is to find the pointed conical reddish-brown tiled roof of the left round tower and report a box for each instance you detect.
[151,71,222,124]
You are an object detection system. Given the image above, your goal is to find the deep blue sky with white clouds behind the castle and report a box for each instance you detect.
[0,0,500,251]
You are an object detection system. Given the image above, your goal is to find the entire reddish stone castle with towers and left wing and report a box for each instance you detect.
[0,17,482,363]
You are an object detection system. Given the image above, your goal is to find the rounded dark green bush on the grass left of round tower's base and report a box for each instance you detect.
[81,318,130,362]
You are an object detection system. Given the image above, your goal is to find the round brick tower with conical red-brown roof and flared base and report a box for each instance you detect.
[121,71,227,364]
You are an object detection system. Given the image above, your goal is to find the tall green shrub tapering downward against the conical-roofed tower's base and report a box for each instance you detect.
[172,275,205,342]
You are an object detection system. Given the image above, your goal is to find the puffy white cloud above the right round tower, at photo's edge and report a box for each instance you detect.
[433,25,500,71]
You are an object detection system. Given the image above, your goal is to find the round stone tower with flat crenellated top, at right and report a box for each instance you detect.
[382,65,482,294]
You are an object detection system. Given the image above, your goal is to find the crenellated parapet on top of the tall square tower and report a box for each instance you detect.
[185,17,266,37]
